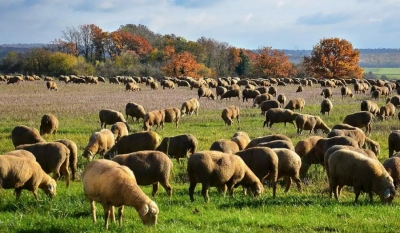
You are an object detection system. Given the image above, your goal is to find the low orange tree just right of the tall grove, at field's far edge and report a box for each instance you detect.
[162,52,201,78]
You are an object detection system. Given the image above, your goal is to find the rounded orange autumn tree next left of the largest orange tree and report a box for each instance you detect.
[253,47,295,78]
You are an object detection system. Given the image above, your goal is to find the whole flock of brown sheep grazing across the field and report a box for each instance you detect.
[0,76,400,228]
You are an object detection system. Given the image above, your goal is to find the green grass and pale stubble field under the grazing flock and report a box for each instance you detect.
[0,81,400,232]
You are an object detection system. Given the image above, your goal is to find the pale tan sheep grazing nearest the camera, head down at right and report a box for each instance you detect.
[82,159,159,229]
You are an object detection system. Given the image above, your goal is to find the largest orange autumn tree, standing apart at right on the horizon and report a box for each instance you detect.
[303,38,363,79]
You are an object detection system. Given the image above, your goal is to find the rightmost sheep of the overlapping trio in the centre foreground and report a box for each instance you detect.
[273,149,301,193]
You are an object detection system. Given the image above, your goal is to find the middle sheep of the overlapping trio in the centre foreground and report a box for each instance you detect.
[236,147,279,198]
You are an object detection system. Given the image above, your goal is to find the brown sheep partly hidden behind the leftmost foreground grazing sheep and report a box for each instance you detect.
[16,142,70,187]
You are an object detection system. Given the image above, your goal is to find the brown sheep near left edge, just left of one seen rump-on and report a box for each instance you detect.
[11,125,46,147]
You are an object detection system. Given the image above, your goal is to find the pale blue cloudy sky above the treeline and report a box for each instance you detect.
[0,0,400,50]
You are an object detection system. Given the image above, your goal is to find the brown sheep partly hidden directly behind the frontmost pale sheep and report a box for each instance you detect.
[112,150,173,197]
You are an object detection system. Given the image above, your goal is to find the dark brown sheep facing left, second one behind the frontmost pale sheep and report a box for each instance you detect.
[104,131,161,159]
